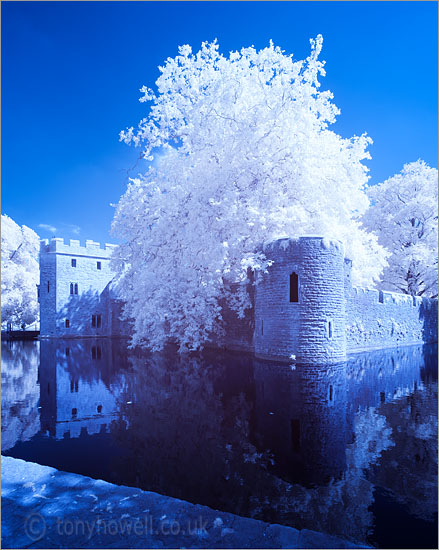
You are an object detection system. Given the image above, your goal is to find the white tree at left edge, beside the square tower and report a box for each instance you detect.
[1,214,40,328]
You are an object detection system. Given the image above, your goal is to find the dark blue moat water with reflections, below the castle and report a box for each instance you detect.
[1,339,438,548]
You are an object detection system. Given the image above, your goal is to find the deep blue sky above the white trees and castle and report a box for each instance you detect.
[1,1,438,242]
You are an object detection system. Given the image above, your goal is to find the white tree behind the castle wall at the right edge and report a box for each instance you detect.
[364,160,438,297]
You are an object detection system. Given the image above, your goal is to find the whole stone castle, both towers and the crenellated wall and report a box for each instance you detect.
[39,236,438,365]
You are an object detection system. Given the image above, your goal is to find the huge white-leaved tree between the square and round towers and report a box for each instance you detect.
[113,36,385,349]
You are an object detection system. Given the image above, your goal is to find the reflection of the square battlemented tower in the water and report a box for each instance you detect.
[39,339,122,439]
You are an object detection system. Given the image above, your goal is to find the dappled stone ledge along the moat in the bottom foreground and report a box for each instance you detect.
[1,456,367,548]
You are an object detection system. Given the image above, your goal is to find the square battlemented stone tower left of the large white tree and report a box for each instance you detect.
[39,238,116,337]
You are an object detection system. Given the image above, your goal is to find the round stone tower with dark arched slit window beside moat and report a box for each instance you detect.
[255,237,346,365]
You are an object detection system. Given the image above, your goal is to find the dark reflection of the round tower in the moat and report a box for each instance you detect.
[255,360,347,484]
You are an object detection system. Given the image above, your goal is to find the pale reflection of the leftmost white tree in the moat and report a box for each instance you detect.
[1,341,40,451]
